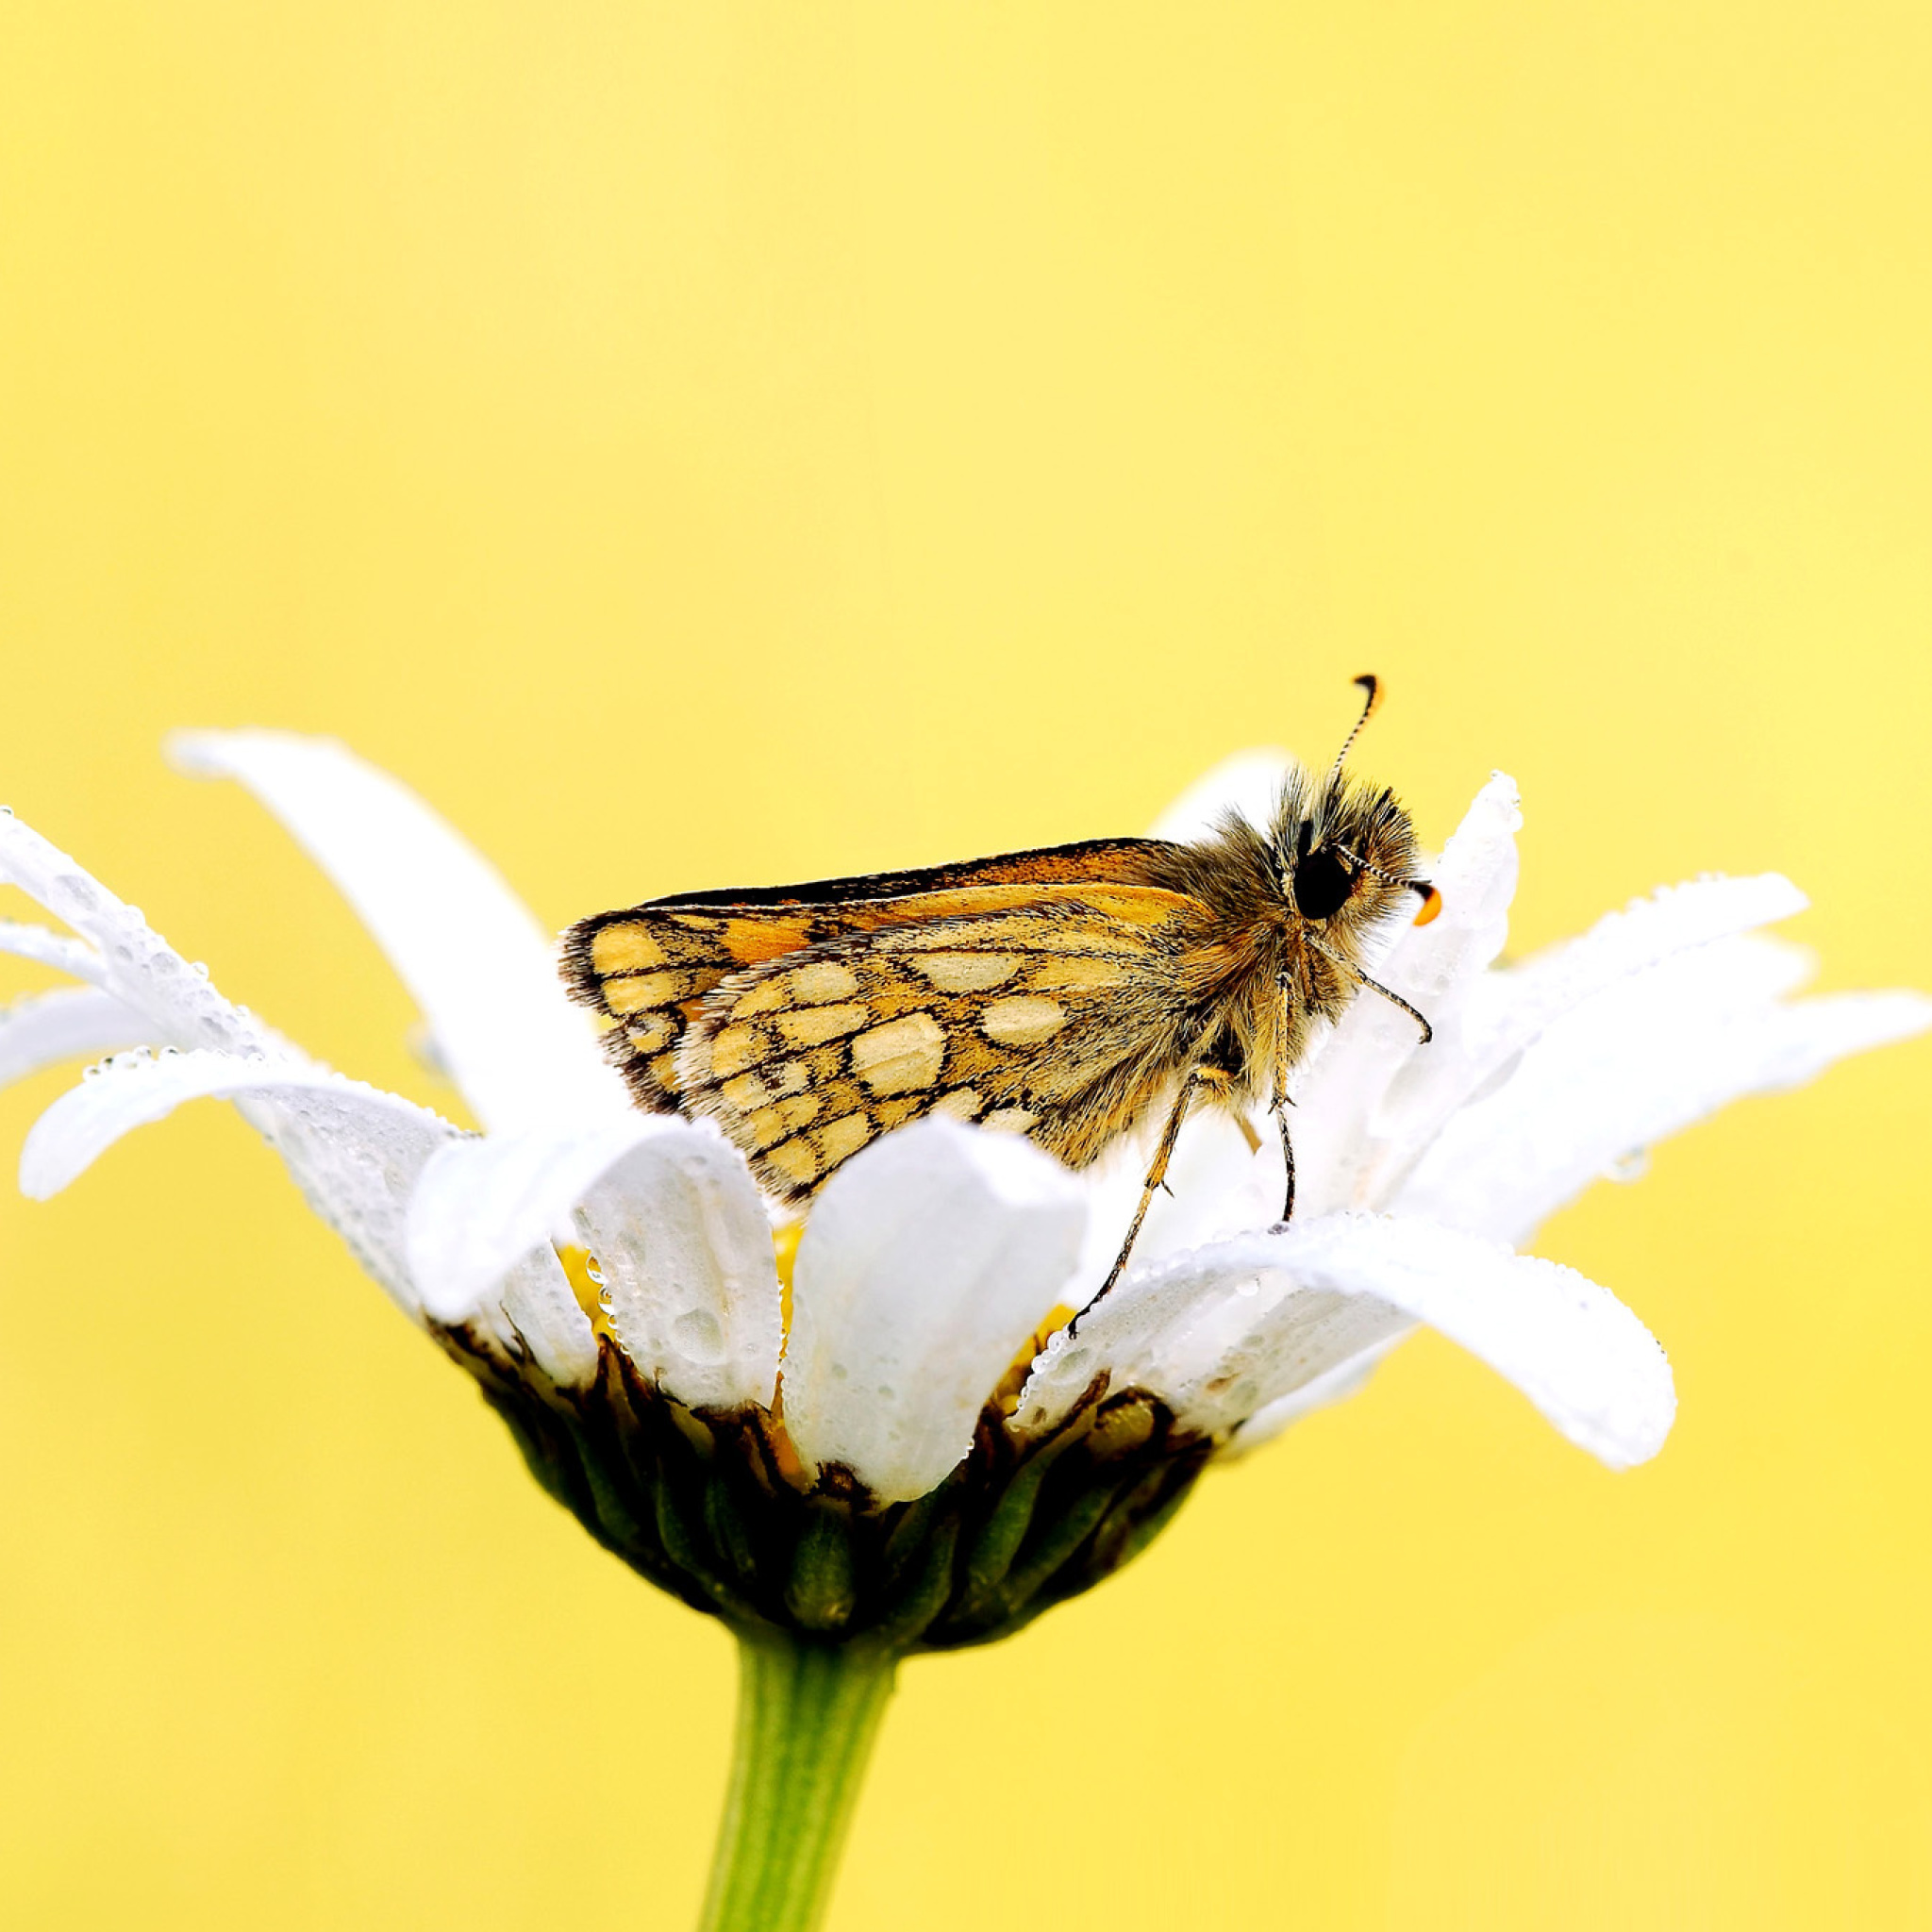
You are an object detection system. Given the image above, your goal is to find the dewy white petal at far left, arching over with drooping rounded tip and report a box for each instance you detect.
[19,1053,456,1312]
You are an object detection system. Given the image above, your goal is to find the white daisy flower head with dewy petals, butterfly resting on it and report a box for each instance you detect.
[0,732,1932,1628]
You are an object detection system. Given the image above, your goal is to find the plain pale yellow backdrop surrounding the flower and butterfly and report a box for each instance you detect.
[0,0,1932,1932]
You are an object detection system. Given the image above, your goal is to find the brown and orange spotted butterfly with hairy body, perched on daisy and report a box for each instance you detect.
[562,676,1441,1292]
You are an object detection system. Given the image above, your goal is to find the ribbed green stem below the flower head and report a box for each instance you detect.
[699,1631,898,1932]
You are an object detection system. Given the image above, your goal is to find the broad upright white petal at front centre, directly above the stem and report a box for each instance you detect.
[784,1121,1086,1501]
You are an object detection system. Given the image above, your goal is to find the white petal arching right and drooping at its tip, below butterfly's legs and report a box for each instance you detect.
[1016,1213,1677,1468]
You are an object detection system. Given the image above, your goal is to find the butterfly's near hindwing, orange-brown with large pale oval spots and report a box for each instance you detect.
[676,885,1206,1200]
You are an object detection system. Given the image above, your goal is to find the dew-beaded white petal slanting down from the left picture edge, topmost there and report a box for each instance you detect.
[0,813,286,1053]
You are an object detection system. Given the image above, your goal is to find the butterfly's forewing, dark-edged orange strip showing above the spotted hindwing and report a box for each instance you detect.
[562,839,1173,1113]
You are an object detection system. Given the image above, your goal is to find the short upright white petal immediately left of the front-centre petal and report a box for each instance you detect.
[575,1121,784,1412]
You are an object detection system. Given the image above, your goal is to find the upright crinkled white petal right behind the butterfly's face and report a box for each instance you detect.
[1289,773,1523,1215]
